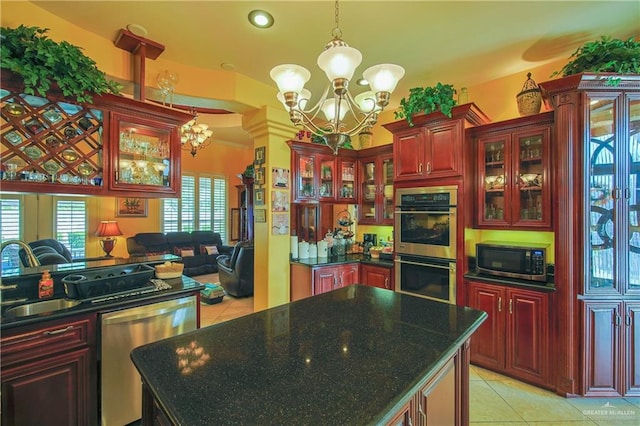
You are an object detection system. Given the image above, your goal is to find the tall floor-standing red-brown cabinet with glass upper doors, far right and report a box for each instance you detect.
[540,73,640,396]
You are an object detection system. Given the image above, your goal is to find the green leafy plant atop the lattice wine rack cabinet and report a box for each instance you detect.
[0,25,122,103]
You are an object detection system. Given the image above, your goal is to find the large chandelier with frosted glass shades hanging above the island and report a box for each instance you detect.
[271,0,404,155]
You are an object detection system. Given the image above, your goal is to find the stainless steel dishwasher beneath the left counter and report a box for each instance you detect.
[100,296,198,426]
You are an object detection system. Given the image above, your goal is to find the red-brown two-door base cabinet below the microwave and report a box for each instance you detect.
[467,281,552,388]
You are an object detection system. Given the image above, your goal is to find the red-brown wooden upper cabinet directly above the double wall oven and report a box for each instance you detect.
[384,103,490,182]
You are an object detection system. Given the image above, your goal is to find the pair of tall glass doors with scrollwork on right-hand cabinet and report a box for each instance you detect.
[584,94,640,295]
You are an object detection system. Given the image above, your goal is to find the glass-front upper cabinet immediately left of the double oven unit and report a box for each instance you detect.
[358,145,394,225]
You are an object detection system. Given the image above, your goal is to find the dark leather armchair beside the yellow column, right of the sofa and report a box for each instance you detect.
[217,241,253,297]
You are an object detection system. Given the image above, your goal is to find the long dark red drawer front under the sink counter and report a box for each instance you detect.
[0,316,95,368]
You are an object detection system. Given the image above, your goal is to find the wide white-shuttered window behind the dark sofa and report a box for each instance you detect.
[162,175,227,241]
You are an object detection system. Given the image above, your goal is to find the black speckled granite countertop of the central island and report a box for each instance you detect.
[131,285,487,425]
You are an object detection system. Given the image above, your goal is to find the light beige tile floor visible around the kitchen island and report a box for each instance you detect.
[194,274,640,426]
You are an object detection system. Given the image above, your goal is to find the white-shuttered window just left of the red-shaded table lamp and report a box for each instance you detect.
[55,199,87,259]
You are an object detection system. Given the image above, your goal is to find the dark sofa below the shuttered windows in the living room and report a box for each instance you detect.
[127,231,233,277]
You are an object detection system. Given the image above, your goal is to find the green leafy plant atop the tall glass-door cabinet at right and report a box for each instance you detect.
[551,36,640,86]
